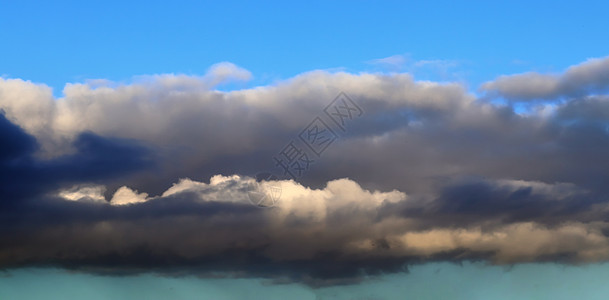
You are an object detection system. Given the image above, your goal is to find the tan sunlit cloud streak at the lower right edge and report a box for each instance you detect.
[390,222,609,263]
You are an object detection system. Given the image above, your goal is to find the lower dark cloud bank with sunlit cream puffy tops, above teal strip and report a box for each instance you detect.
[0,175,609,286]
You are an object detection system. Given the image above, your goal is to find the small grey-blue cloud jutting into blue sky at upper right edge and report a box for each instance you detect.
[480,57,609,101]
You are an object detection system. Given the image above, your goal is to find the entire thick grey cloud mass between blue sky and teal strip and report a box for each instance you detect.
[0,59,609,285]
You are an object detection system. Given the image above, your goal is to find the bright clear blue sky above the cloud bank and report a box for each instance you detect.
[0,1,609,95]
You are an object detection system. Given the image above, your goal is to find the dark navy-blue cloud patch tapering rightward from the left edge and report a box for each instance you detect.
[0,113,153,205]
